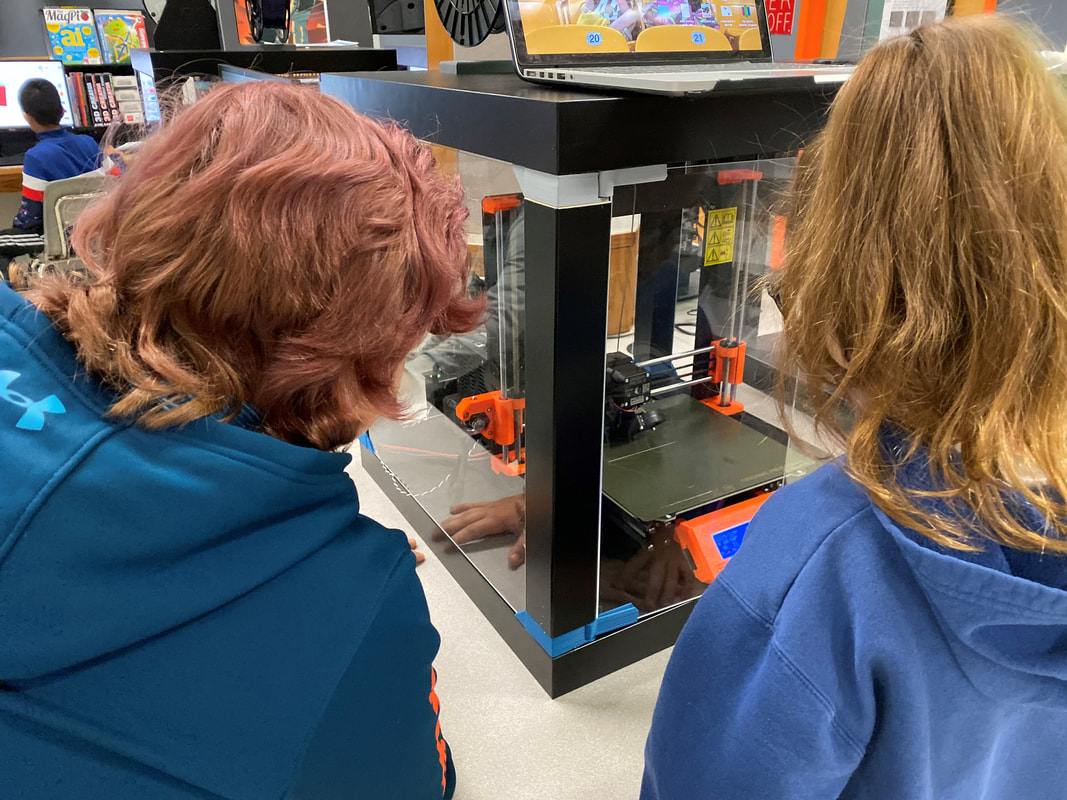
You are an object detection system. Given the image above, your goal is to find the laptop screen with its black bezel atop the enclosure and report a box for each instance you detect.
[508,0,770,64]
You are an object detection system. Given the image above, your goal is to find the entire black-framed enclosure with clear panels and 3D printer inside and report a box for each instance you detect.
[322,57,835,697]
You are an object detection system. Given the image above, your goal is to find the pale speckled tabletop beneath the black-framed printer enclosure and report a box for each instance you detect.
[349,458,669,800]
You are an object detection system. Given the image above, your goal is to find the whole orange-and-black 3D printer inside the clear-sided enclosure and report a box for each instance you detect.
[401,160,806,611]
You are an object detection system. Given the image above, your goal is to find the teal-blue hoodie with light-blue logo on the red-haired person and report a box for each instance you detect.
[0,287,452,800]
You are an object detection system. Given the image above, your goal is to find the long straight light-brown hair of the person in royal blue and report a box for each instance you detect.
[778,17,1067,554]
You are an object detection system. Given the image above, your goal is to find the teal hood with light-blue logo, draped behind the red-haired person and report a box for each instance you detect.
[0,287,359,682]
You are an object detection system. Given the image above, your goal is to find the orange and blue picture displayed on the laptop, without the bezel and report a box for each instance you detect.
[519,0,764,55]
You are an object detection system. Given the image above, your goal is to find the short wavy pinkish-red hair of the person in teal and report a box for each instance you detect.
[27,82,482,449]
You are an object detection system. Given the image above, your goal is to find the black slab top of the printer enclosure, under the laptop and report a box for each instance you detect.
[321,71,837,175]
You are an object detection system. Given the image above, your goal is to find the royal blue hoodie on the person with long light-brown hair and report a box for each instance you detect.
[641,456,1067,800]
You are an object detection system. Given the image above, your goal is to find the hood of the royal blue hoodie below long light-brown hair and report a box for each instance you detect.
[874,445,1067,709]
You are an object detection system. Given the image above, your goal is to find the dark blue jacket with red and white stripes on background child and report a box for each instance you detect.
[13,128,100,233]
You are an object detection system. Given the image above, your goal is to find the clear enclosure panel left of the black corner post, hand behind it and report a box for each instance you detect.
[370,147,526,611]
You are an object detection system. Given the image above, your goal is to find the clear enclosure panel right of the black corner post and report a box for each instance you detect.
[600,158,819,614]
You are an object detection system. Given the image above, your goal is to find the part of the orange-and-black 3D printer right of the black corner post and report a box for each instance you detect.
[603,166,791,592]
